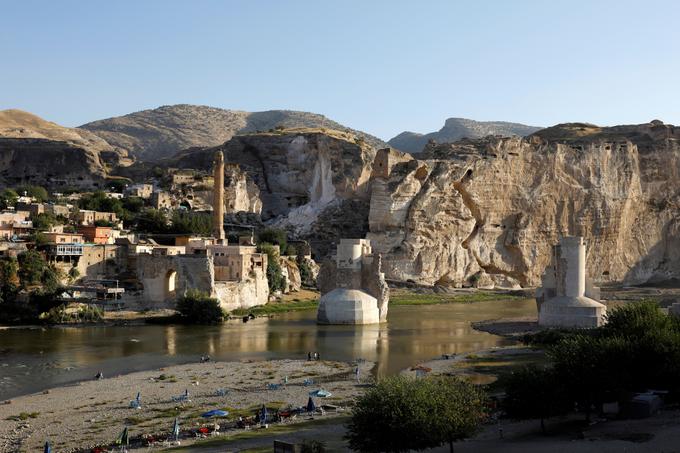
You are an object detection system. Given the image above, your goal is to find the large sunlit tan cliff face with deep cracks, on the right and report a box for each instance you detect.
[367,122,680,286]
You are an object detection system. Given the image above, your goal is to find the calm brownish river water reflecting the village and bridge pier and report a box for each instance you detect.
[0,300,536,399]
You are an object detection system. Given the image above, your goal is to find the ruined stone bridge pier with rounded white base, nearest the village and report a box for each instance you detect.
[317,239,389,324]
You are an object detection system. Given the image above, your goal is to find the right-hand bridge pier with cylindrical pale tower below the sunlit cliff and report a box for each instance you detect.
[536,236,607,327]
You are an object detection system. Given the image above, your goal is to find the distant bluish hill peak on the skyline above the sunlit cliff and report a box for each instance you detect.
[387,118,540,153]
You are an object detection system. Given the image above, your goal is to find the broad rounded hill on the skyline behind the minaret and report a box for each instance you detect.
[80,104,386,161]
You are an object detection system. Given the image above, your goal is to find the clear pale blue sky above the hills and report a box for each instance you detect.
[0,0,680,139]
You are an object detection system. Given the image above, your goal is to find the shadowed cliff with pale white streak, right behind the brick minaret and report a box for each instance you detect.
[168,129,375,246]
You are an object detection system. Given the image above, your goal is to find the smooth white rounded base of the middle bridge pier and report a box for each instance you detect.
[317,288,380,324]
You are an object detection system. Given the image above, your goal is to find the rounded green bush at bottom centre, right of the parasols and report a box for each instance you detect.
[346,376,485,452]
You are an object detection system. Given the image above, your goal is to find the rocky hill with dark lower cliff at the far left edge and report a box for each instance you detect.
[0,110,131,187]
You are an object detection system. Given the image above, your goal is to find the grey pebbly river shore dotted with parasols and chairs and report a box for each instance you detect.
[0,360,373,452]
